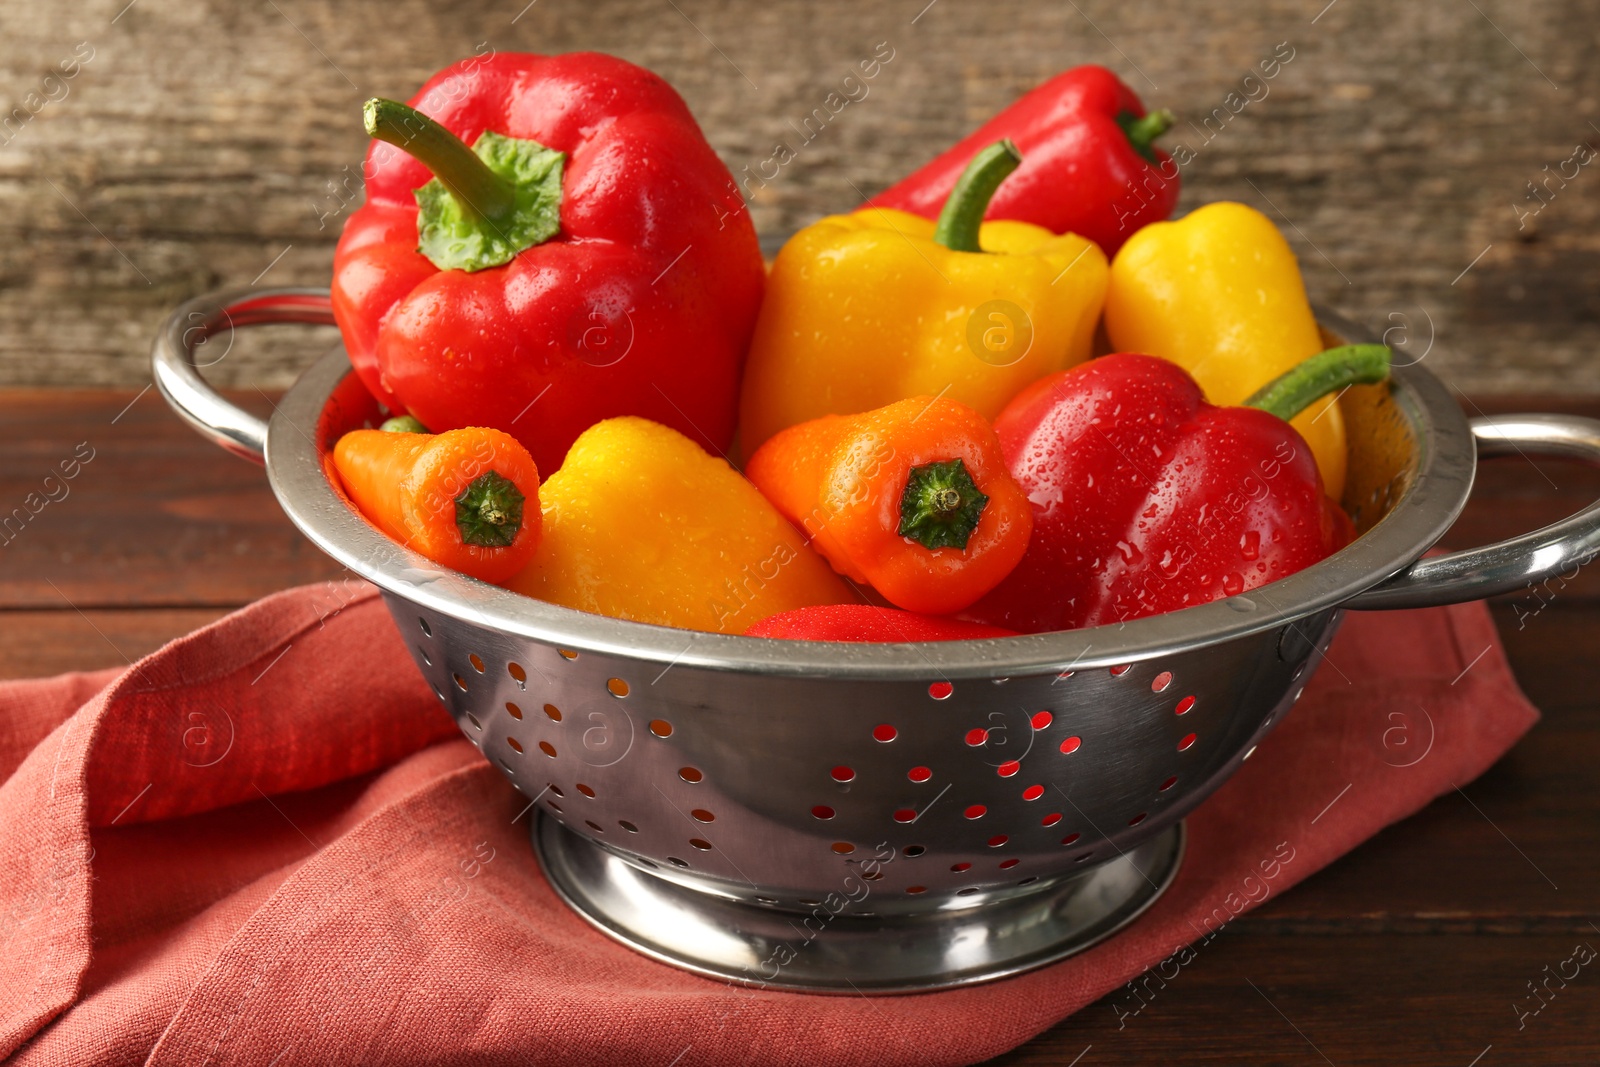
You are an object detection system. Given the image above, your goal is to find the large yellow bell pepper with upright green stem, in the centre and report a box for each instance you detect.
[739,142,1107,456]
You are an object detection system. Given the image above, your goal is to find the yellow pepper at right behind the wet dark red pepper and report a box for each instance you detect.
[1106,203,1346,499]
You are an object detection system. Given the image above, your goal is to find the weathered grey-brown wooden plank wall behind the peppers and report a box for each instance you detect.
[0,0,1600,395]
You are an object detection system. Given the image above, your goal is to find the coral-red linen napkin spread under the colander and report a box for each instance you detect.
[0,587,1538,1067]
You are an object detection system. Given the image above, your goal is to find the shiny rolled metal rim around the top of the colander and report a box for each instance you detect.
[266,309,1477,681]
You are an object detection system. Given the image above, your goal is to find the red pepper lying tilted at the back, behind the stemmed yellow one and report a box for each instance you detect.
[872,66,1179,256]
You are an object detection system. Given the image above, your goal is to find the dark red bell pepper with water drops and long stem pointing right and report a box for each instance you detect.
[962,344,1389,633]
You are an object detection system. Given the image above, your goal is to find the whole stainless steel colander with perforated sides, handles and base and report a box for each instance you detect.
[152,290,1600,992]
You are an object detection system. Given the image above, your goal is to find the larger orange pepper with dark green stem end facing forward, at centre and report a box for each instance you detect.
[744,397,1034,614]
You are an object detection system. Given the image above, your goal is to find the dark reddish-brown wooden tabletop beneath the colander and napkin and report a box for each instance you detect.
[0,382,1600,1067]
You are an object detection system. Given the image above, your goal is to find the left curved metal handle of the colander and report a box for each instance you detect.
[150,288,333,464]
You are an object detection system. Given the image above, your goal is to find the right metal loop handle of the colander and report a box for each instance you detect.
[1344,414,1600,609]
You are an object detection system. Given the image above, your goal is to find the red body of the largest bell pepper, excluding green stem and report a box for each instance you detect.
[333,53,763,470]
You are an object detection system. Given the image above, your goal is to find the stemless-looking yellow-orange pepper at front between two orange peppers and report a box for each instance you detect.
[509,416,858,633]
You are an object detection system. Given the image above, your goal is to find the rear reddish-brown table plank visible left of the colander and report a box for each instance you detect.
[0,389,339,609]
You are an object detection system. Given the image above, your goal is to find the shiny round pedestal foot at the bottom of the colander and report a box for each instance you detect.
[533,814,1184,993]
